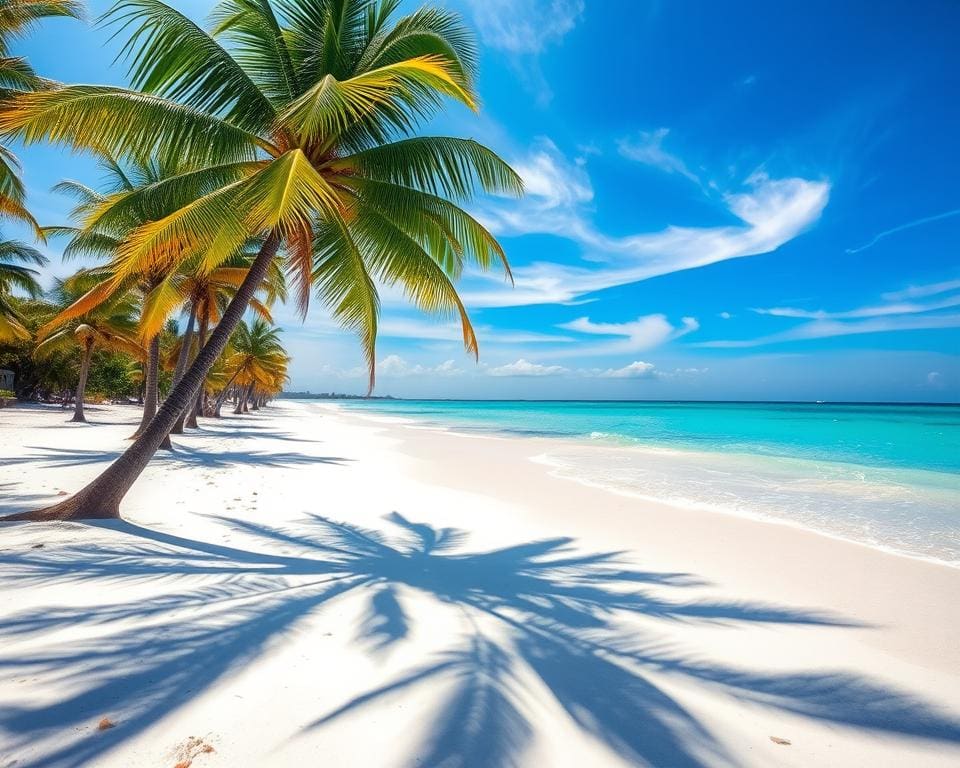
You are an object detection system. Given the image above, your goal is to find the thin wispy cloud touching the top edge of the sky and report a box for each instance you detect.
[467,0,584,54]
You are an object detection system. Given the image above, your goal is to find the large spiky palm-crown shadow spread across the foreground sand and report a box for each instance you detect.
[0,512,960,766]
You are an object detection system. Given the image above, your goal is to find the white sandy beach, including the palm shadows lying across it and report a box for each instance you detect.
[0,402,960,768]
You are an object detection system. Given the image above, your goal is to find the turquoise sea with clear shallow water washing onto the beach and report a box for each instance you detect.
[336,400,960,566]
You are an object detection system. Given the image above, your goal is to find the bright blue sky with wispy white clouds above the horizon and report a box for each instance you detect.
[9,0,960,401]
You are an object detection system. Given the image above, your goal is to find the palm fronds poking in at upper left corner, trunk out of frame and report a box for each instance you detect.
[0,0,81,231]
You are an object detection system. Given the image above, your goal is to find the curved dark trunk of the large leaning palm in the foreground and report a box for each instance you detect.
[11,232,280,520]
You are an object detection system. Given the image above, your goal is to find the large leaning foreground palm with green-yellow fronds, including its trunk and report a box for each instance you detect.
[0,0,522,519]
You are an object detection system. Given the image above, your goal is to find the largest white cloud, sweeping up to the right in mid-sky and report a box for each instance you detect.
[463,140,830,307]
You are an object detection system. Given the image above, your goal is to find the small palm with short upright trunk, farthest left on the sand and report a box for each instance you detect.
[34,271,144,422]
